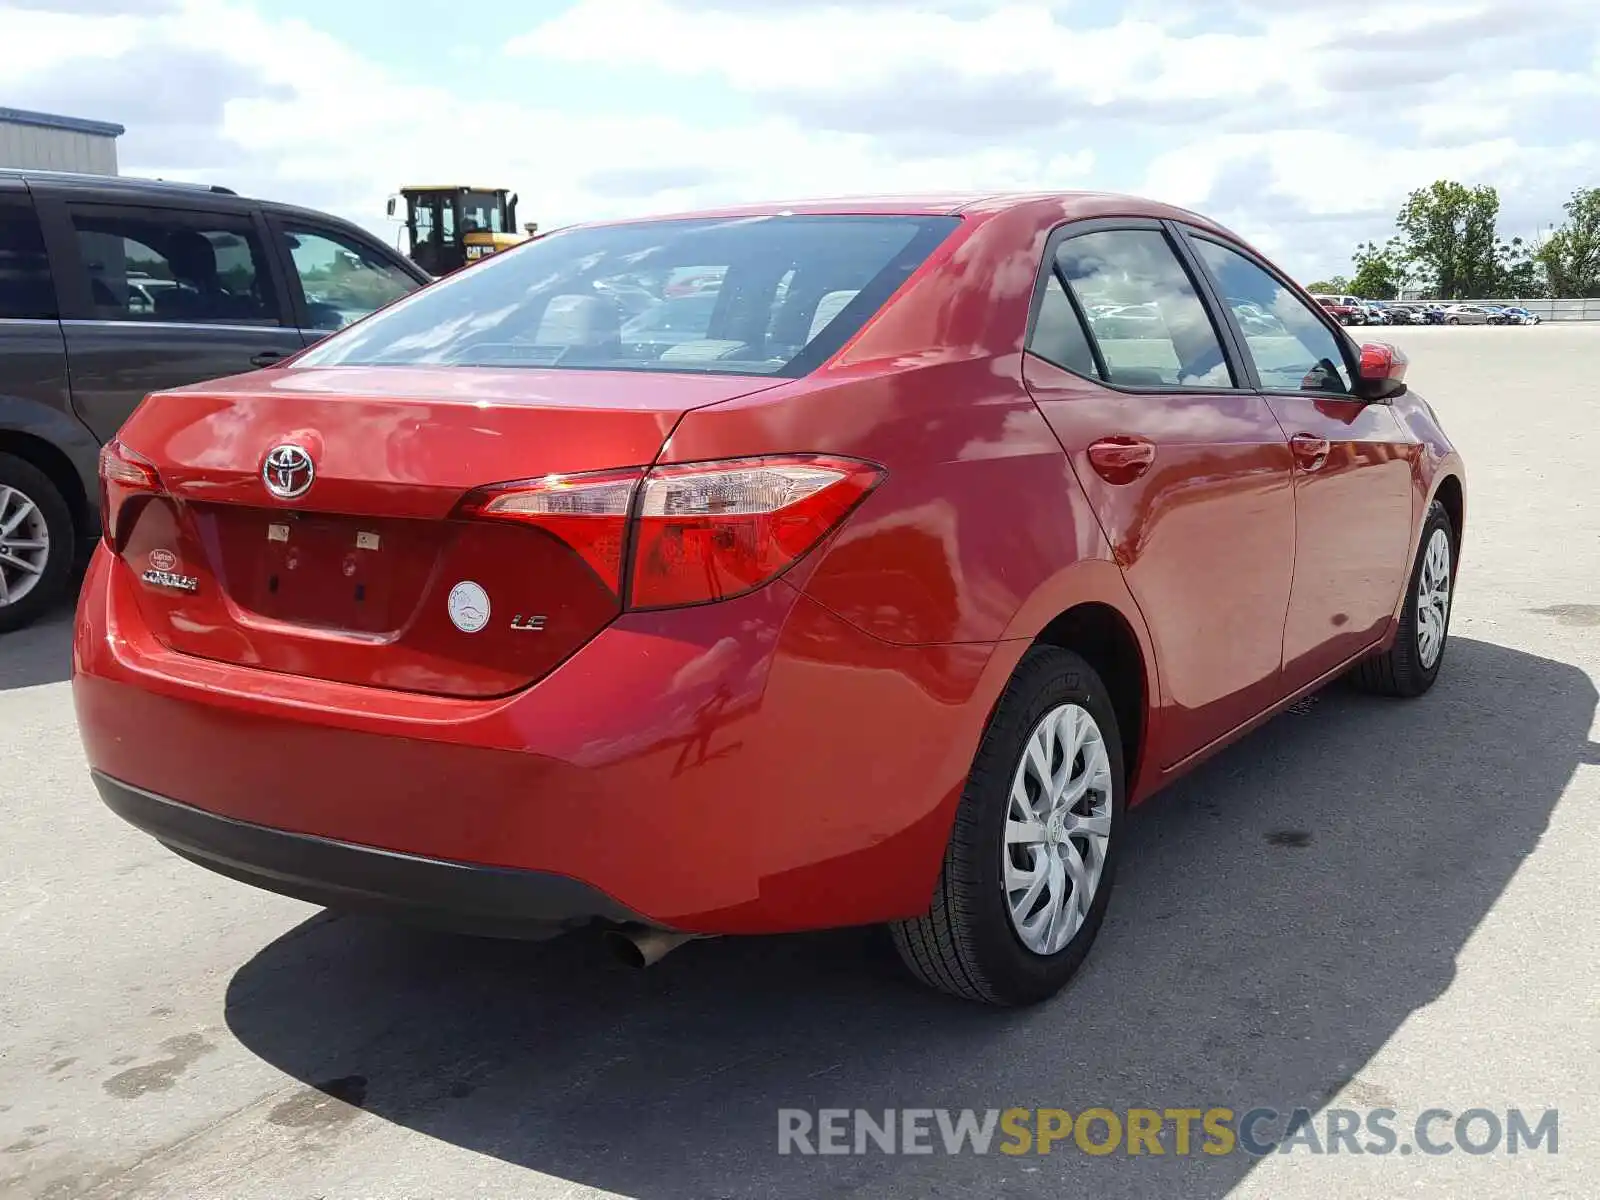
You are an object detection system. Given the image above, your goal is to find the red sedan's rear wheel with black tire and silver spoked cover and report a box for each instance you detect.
[891,646,1126,1005]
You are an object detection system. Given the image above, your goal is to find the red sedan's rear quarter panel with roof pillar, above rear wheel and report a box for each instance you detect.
[659,204,1158,819]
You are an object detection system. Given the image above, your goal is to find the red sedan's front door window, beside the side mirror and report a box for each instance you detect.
[1192,237,1350,395]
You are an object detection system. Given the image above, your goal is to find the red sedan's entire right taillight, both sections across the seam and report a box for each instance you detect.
[458,454,883,608]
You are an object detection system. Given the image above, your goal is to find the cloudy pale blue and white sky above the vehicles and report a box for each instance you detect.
[0,0,1600,278]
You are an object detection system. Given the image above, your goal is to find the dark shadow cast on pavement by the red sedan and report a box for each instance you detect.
[227,638,1595,1200]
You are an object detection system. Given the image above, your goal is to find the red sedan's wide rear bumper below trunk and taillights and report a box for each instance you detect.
[72,547,1026,934]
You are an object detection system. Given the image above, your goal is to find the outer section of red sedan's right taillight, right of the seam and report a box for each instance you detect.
[629,454,883,608]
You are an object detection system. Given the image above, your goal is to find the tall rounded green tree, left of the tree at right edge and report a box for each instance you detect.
[1395,179,1502,299]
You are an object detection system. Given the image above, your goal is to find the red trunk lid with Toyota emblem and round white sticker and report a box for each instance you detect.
[112,368,779,696]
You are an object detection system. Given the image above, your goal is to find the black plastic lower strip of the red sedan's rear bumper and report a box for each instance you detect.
[93,771,642,938]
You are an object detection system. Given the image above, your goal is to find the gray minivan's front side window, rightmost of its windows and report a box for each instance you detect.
[267,211,426,346]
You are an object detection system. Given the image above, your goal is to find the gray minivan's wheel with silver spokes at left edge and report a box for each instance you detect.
[0,454,74,634]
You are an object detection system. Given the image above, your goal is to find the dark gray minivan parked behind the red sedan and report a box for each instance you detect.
[0,170,429,634]
